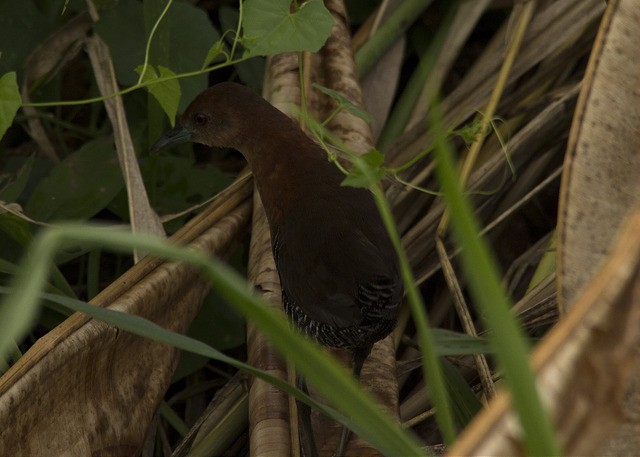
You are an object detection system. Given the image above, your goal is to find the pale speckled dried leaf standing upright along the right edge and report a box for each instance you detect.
[558,0,640,455]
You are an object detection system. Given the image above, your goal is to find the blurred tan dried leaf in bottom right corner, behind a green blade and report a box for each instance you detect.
[448,205,640,455]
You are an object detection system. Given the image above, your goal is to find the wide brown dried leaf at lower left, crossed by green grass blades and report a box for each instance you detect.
[0,176,251,455]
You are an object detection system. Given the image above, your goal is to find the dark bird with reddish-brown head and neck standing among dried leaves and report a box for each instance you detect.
[150,82,404,456]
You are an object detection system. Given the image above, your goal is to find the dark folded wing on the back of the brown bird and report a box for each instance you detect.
[272,203,398,328]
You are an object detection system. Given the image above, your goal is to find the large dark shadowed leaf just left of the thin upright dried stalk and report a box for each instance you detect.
[25,140,124,221]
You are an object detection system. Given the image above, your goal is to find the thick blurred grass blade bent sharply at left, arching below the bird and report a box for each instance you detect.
[0,224,422,455]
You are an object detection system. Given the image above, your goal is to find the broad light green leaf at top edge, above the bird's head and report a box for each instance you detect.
[243,0,333,56]
